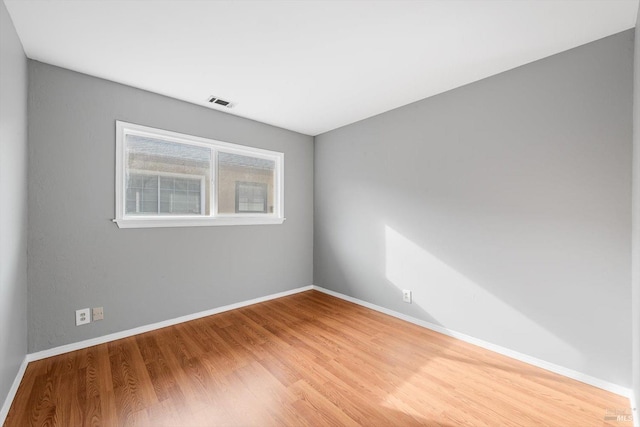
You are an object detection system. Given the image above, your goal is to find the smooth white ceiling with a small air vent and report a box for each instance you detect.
[4,0,638,135]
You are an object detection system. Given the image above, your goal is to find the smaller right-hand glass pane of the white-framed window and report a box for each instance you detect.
[218,152,276,214]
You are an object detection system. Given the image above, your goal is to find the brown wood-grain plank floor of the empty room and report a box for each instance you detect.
[5,291,632,427]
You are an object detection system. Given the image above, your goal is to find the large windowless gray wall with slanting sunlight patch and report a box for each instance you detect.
[314,30,633,387]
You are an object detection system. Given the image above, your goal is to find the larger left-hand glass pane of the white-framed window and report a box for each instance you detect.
[125,135,211,215]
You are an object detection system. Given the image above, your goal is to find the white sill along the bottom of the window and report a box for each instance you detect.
[112,216,285,228]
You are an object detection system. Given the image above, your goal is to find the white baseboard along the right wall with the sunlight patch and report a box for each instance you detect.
[313,285,637,400]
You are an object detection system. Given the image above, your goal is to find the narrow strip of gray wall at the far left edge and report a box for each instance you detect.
[0,1,27,412]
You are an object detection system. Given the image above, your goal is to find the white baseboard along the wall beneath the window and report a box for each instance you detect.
[27,286,313,362]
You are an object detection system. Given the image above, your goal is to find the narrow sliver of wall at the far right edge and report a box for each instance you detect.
[631,9,640,419]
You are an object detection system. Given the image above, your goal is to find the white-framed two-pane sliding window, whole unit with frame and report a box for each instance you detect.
[114,121,284,228]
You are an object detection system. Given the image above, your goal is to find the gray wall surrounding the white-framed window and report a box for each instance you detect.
[28,61,313,352]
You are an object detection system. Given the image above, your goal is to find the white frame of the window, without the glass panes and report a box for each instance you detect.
[113,120,285,228]
